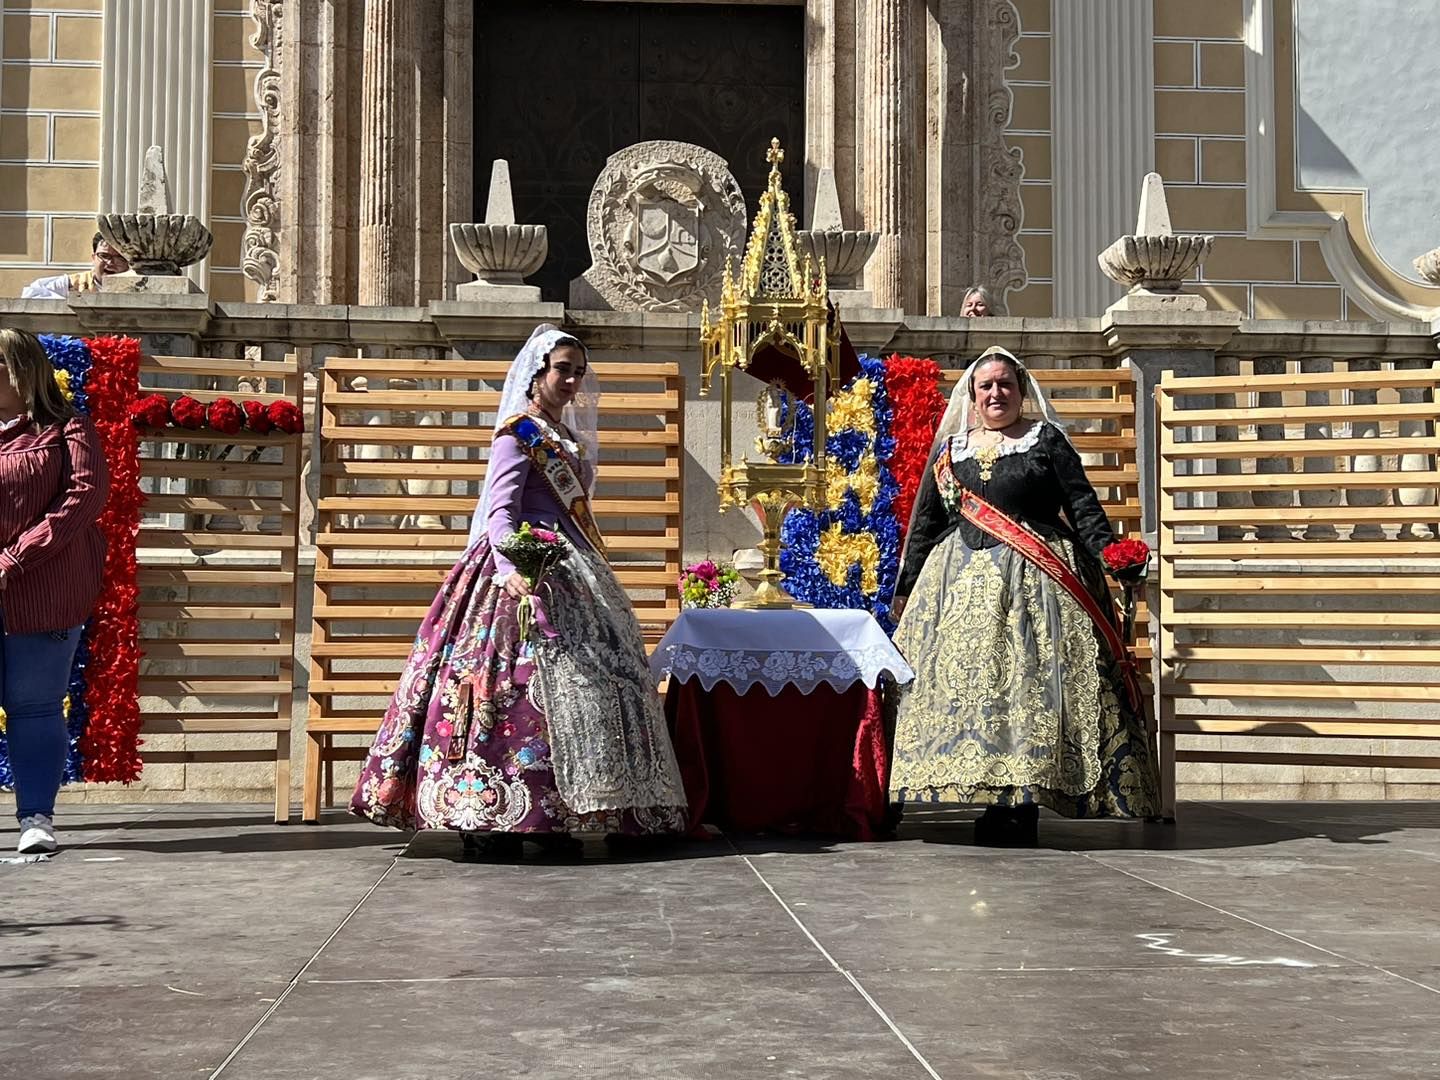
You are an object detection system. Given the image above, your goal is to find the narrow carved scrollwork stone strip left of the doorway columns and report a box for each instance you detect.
[240,0,284,304]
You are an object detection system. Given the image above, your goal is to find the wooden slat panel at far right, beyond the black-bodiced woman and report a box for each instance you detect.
[1158,357,1440,811]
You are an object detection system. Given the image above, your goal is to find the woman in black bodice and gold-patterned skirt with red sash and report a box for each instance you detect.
[891,347,1159,845]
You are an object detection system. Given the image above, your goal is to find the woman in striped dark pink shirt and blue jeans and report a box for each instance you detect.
[0,330,109,854]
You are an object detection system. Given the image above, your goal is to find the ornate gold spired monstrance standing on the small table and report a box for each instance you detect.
[700,138,840,608]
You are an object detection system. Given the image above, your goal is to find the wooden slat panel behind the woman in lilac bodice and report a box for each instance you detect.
[304,357,684,821]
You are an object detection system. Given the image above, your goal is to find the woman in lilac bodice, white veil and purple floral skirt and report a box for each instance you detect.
[351,325,685,861]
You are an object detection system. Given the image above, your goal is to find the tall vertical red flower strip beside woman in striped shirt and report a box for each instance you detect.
[81,337,144,783]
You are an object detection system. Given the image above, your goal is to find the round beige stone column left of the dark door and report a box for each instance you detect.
[360,0,416,307]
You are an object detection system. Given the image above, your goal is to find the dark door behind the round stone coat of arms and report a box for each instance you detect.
[474,0,805,301]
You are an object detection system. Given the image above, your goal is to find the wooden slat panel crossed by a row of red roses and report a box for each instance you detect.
[137,356,304,821]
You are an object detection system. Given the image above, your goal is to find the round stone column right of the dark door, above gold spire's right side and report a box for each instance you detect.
[861,0,922,311]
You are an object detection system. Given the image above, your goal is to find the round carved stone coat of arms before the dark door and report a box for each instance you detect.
[570,140,746,311]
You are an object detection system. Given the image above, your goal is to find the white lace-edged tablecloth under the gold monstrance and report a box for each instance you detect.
[649,608,914,696]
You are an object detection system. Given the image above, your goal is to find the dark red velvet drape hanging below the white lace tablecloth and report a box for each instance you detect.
[665,680,890,840]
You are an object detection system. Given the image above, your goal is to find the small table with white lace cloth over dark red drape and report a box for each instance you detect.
[651,608,914,840]
